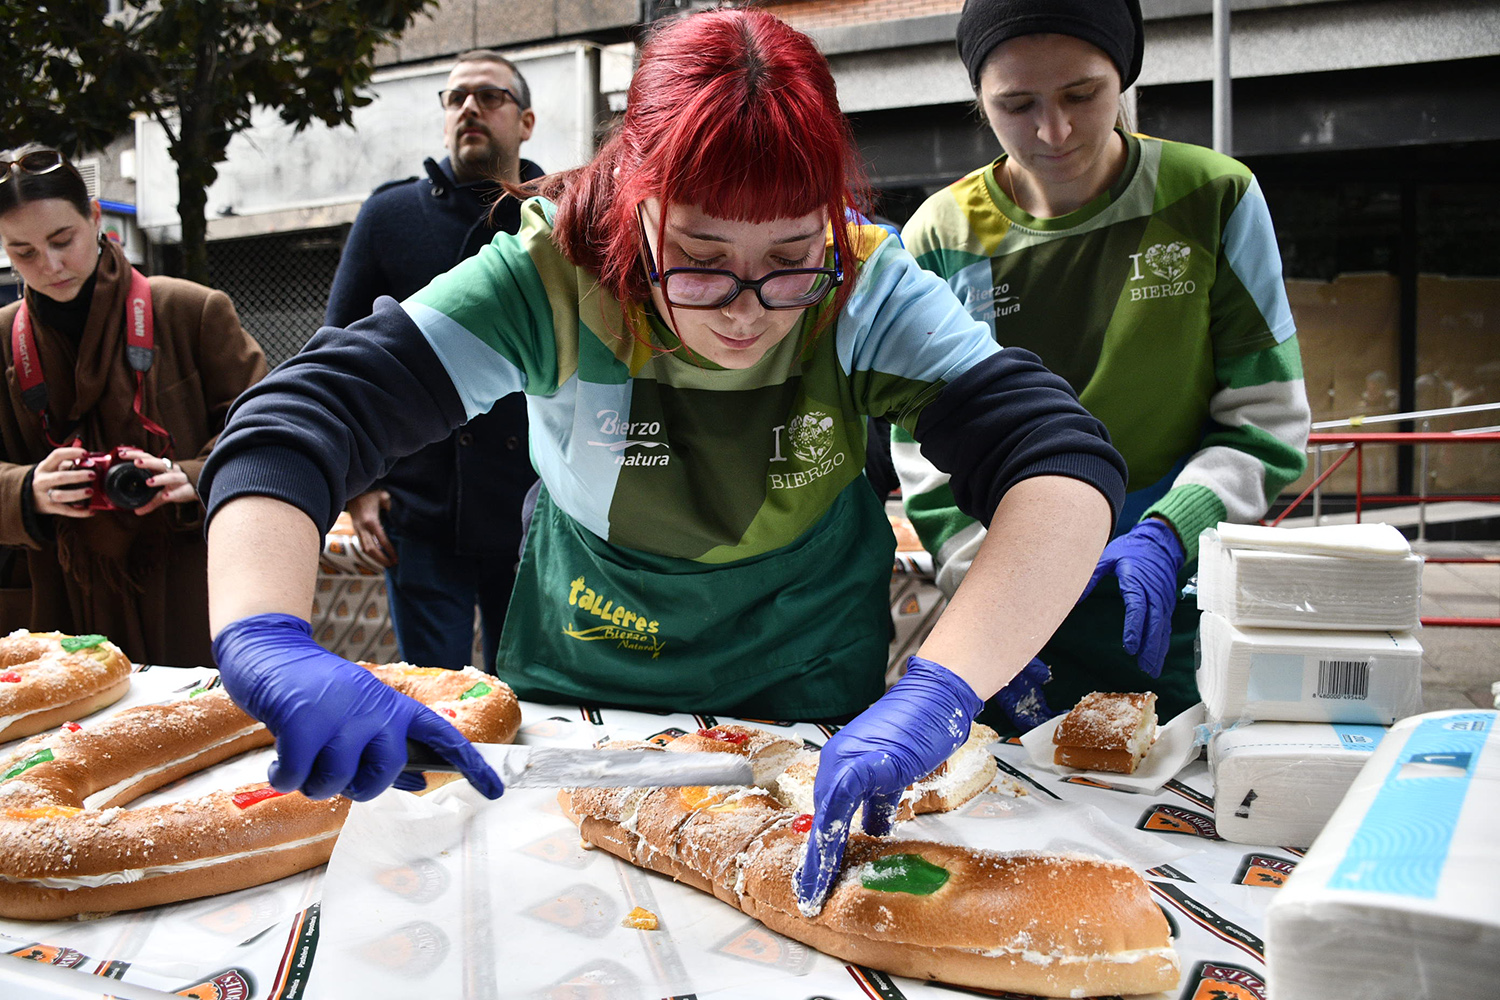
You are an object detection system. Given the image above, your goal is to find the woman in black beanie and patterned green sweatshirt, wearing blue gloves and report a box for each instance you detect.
[893,0,1310,729]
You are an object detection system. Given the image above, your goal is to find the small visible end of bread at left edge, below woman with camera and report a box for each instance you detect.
[0,628,134,742]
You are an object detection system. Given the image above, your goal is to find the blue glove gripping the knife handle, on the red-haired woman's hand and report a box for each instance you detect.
[213,615,506,801]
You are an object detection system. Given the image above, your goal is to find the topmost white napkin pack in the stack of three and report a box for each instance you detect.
[1199,523,1422,631]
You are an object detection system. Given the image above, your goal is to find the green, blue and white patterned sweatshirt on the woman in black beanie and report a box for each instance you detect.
[893,135,1310,592]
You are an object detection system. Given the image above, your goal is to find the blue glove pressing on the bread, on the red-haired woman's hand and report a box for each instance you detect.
[797,657,984,916]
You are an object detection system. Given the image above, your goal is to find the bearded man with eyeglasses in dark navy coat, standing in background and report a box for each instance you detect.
[326,49,543,670]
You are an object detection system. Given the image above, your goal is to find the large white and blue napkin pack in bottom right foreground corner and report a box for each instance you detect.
[1266,709,1500,1000]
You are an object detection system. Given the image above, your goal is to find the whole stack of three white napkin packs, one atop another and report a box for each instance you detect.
[1197,523,1422,847]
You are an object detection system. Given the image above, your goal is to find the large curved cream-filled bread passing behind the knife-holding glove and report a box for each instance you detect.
[0,664,521,919]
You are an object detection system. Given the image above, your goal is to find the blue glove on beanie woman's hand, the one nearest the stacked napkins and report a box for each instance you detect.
[1079,517,1188,678]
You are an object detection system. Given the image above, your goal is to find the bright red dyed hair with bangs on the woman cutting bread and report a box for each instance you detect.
[539,9,867,344]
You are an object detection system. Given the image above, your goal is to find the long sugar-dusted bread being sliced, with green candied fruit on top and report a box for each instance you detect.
[558,722,1179,997]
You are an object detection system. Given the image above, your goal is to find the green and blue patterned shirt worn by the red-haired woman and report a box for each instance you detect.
[402,199,999,564]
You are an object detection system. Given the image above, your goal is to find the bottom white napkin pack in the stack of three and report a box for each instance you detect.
[1209,723,1386,847]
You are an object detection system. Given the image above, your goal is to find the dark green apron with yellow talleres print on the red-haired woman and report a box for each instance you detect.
[495,475,896,720]
